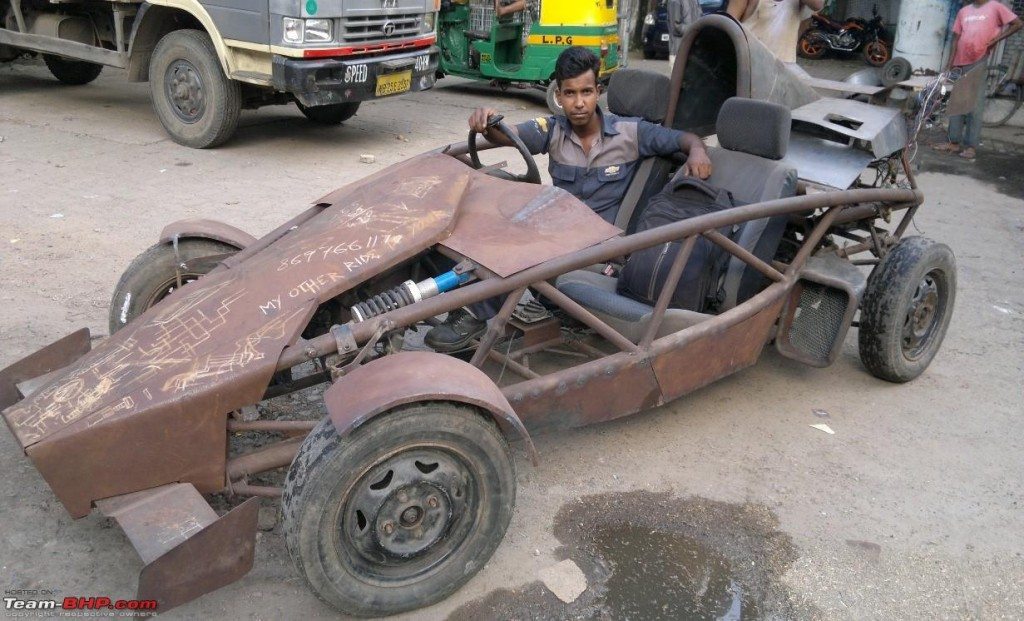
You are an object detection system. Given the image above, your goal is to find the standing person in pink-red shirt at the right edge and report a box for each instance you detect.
[935,0,1024,160]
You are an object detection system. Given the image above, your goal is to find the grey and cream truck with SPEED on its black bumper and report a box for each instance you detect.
[0,0,440,149]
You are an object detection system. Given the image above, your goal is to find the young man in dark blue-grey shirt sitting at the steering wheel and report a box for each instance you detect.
[424,47,711,351]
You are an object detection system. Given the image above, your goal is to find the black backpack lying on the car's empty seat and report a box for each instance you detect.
[616,177,745,313]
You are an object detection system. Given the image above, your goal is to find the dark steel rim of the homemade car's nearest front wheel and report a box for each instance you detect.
[332,446,480,586]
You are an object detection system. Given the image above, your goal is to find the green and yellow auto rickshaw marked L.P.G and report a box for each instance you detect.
[437,0,620,114]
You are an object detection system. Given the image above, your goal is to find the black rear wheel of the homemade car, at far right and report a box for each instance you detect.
[858,237,956,383]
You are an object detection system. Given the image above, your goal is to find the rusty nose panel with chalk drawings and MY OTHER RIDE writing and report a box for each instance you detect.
[4,156,471,516]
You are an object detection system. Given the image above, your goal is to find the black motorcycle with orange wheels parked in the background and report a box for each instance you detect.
[797,6,892,67]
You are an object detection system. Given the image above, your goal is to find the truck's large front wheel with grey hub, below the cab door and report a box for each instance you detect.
[150,30,242,149]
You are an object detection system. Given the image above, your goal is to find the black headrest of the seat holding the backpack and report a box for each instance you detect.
[716,97,793,160]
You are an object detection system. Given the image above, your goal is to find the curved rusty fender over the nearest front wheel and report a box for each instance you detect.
[324,351,537,463]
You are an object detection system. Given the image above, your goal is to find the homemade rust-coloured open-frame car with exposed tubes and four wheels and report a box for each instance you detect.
[0,16,955,615]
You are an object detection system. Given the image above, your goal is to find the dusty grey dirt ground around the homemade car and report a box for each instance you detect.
[0,54,1024,619]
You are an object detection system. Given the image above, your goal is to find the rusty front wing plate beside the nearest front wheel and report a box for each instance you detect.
[96,483,259,613]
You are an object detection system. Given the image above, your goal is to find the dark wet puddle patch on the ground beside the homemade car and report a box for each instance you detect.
[450,492,814,621]
